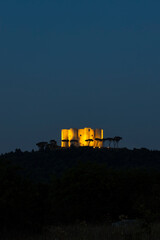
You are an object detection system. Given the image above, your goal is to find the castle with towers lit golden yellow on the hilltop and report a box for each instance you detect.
[61,128,103,148]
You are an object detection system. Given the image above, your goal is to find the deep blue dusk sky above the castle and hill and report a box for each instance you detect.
[0,0,160,152]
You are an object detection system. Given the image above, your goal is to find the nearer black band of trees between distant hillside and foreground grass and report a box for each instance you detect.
[0,160,160,233]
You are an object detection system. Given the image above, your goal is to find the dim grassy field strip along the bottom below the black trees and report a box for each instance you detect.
[2,222,160,240]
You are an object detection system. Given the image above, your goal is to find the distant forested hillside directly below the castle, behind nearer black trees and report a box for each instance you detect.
[0,148,160,182]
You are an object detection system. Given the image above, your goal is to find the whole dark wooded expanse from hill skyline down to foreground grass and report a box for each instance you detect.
[0,148,160,237]
